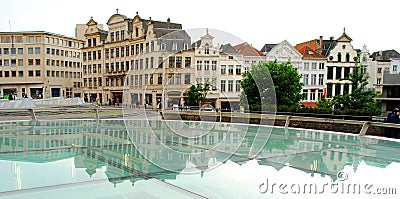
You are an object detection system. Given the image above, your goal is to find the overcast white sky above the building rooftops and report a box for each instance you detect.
[0,0,400,53]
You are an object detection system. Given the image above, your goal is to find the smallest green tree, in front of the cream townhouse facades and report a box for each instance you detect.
[186,82,210,106]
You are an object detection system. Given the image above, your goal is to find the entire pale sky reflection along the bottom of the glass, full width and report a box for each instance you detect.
[0,158,400,198]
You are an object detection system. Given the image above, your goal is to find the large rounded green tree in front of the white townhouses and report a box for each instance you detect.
[240,61,303,110]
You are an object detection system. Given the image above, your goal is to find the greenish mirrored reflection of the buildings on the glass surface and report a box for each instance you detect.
[0,120,397,187]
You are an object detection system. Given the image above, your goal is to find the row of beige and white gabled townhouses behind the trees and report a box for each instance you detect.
[0,13,400,110]
